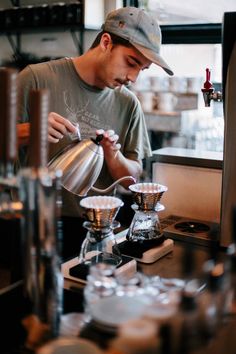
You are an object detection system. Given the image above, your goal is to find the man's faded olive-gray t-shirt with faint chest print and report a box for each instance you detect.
[18,58,151,216]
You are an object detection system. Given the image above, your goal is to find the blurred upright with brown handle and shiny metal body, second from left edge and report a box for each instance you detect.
[19,90,63,350]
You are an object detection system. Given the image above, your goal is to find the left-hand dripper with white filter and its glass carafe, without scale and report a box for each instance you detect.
[79,196,124,266]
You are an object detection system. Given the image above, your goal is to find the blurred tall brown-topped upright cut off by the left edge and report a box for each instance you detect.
[0,67,22,353]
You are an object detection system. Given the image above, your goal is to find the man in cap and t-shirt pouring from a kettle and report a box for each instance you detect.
[18,7,173,260]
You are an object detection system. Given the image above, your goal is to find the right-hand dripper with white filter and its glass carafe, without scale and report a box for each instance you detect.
[127,183,167,242]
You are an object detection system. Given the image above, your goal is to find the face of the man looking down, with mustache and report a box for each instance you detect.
[96,44,151,89]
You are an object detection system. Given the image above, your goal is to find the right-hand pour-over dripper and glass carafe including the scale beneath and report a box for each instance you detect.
[119,183,173,263]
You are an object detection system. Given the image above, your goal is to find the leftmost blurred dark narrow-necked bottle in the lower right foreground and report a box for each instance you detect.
[163,243,201,354]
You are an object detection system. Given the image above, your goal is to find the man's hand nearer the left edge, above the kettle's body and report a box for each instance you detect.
[48,112,77,143]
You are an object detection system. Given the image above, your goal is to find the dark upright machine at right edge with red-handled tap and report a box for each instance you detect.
[202,12,236,247]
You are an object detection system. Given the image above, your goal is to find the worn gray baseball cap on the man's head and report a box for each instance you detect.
[102,6,174,75]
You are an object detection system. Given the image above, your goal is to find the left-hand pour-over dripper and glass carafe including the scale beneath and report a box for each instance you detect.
[61,196,136,282]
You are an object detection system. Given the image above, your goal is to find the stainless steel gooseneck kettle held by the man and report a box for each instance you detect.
[49,135,136,196]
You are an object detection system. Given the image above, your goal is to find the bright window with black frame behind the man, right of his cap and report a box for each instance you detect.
[130,0,236,152]
